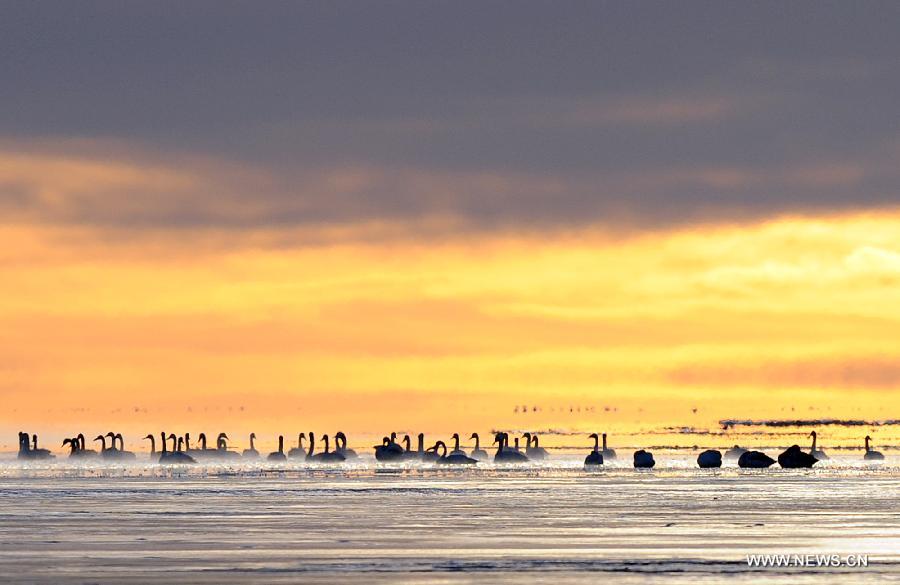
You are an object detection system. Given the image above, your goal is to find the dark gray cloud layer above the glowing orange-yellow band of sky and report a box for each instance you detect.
[0,2,900,234]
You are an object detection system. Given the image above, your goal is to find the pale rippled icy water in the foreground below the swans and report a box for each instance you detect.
[0,454,900,583]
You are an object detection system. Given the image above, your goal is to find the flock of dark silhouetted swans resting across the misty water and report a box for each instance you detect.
[18,431,884,469]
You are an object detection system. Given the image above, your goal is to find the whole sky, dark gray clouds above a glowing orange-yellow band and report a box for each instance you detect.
[0,1,900,448]
